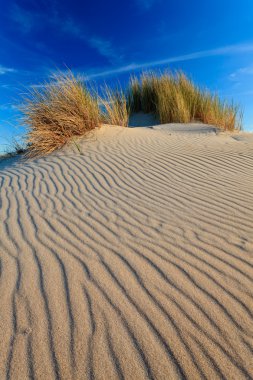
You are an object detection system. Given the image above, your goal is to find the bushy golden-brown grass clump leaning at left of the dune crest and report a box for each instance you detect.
[21,72,100,157]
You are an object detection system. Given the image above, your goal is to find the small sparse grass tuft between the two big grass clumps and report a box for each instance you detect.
[99,86,129,127]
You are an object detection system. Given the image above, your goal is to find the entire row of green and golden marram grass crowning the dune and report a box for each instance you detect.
[21,71,242,157]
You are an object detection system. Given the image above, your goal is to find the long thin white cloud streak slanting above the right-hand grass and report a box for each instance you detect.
[86,43,253,79]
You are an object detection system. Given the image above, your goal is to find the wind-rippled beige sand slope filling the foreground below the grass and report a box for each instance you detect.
[0,125,253,380]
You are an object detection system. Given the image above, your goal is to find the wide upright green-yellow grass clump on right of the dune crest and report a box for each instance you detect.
[127,72,242,131]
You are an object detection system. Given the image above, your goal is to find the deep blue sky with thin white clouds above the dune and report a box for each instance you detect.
[0,0,253,150]
